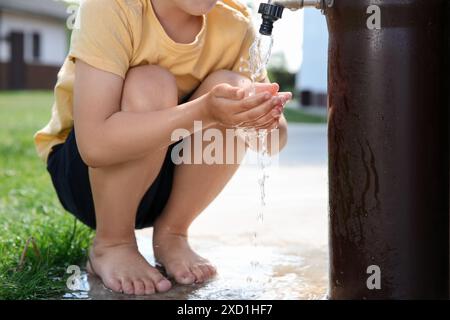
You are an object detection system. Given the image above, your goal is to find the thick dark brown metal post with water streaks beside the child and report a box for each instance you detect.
[327,0,449,299]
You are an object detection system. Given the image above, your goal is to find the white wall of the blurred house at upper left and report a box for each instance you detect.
[0,12,67,66]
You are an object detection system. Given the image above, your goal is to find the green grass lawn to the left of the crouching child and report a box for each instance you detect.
[0,92,92,299]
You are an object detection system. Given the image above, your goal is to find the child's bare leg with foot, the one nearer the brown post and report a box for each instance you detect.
[153,71,250,284]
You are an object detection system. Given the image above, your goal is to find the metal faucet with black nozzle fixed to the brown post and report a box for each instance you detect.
[258,0,334,36]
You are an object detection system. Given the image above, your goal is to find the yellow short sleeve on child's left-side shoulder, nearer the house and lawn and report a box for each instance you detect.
[69,0,133,78]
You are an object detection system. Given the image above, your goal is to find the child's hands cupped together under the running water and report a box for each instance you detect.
[206,84,286,128]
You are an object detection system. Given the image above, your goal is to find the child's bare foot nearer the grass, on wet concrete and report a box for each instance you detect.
[87,241,171,295]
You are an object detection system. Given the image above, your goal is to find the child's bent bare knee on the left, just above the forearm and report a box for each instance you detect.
[122,65,178,112]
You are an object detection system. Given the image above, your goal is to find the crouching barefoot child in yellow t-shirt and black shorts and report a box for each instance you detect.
[35,0,291,295]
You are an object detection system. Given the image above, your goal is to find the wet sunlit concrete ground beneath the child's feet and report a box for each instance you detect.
[66,125,328,299]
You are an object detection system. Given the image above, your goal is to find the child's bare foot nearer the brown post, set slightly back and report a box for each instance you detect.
[153,228,216,284]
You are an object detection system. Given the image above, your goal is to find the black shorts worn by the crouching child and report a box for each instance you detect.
[47,130,177,229]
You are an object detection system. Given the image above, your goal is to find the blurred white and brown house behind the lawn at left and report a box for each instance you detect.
[0,0,68,90]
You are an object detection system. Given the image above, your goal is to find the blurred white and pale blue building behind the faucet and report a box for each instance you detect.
[246,0,328,107]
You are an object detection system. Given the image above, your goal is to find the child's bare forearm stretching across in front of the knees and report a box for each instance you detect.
[76,97,212,167]
